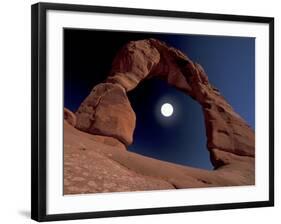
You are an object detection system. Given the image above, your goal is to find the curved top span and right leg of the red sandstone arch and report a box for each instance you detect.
[104,39,255,164]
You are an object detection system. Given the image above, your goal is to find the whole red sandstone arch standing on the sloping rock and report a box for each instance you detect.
[76,39,255,172]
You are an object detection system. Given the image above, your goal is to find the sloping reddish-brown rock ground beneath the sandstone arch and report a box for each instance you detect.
[64,117,255,194]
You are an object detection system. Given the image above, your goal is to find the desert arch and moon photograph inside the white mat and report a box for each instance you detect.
[61,27,256,195]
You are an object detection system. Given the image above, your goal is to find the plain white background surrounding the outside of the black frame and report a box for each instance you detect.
[0,0,281,224]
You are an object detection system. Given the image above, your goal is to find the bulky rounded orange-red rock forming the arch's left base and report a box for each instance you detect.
[76,83,136,145]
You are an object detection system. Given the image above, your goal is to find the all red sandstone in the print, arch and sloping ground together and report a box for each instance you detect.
[64,39,255,194]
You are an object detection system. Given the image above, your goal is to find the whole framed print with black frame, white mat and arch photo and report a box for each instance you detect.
[31,3,274,221]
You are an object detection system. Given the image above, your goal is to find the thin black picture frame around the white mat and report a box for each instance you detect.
[31,3,274,221]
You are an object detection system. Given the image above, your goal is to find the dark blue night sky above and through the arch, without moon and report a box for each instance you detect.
[64,29,255,169]
